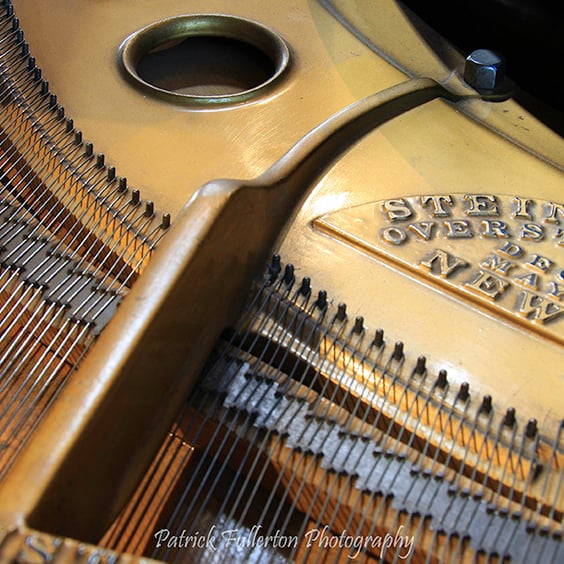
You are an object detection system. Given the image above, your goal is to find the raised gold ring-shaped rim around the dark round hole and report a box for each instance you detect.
[119,14,291,108]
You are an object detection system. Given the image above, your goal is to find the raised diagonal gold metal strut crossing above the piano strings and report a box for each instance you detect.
[0,75,449,540]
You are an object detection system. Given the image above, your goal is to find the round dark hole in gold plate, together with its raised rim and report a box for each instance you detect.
[120,15,290,107]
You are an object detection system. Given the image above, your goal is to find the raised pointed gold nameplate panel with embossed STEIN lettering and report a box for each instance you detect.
[314,194,564,344]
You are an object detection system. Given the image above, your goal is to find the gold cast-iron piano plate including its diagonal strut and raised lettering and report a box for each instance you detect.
[0,0,564,558]
